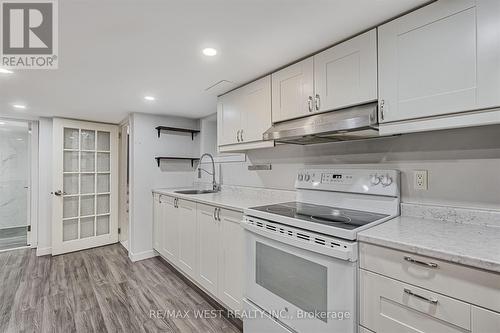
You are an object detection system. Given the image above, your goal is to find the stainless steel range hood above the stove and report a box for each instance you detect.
[263,103,379,145]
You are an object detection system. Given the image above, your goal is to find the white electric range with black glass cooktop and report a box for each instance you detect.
[242,169,400,333]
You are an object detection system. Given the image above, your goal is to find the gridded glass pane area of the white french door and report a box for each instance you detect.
[62,127,111,242]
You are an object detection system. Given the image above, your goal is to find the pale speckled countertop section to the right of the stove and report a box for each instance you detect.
[358,207,500,273]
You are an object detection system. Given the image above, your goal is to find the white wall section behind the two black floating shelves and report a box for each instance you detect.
[129,113,200,260]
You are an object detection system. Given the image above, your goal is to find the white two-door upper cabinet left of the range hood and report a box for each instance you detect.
[217,75,271,151]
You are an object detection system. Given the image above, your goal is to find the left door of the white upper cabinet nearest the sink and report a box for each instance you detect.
[217,89,243,146]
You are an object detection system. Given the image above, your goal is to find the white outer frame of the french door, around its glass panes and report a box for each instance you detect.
[51,118,120,255]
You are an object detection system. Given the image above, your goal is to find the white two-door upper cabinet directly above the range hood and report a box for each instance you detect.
[272,29,377,122]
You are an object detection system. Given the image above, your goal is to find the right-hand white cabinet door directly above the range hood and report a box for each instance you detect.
[314,29,377,112]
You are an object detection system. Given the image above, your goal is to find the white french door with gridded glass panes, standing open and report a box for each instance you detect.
[52,118,118,255]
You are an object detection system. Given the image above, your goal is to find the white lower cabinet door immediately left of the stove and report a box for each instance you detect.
[218,209,245,311]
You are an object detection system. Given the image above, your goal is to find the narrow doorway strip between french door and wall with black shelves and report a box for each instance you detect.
[118,122,130,250]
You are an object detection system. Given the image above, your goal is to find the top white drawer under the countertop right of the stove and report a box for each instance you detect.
[359,243,500,311]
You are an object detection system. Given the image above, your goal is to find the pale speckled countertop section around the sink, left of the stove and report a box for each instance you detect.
[153,185,295,212]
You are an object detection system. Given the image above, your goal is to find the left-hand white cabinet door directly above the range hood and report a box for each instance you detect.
[271,57,314,123]
